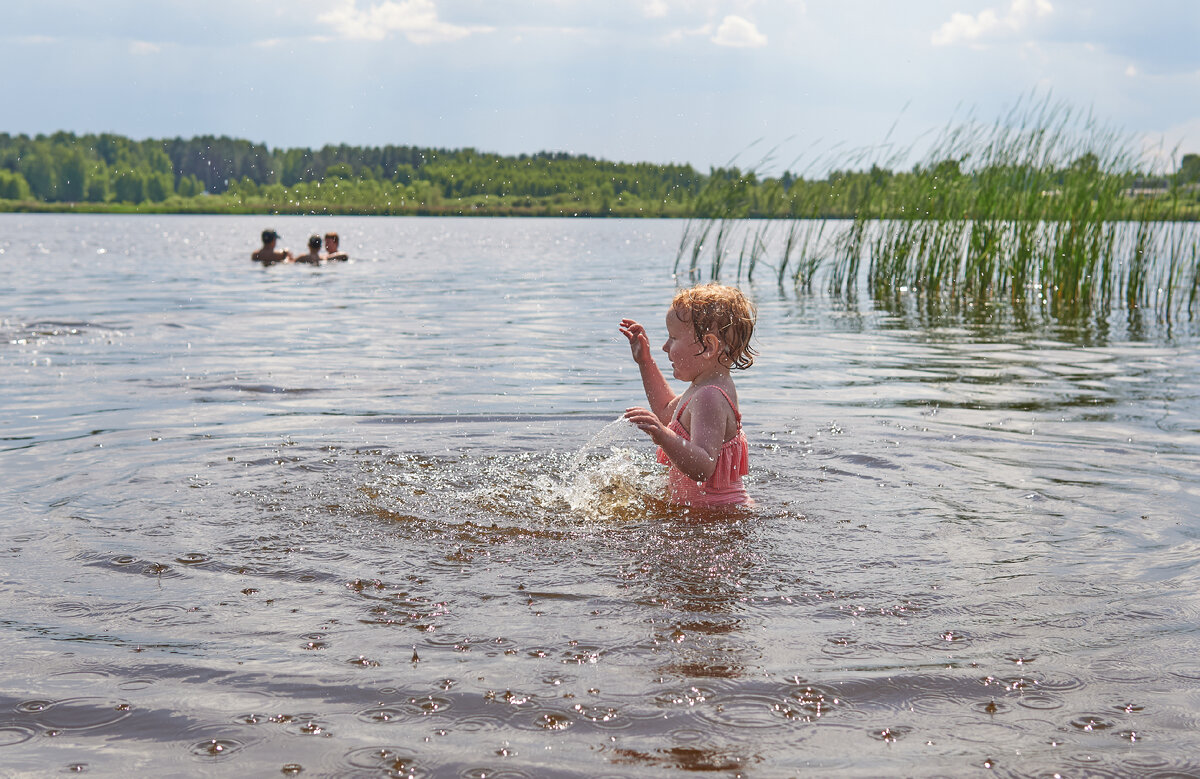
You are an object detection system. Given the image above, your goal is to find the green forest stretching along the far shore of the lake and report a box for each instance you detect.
[0,132,1200,218]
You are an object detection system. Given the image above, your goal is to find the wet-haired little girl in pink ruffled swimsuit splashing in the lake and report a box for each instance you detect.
[620,283,755,507]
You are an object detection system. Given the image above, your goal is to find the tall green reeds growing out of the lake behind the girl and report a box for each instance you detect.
[680,97,1200,317]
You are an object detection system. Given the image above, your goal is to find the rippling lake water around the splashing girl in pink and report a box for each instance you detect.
[0,215,1200,777]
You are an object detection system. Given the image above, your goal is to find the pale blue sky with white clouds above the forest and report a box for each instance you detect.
[0,0,1200,172]
